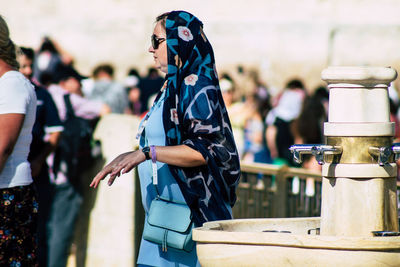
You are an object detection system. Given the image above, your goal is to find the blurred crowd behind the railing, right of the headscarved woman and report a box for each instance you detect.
[220,66,400,170]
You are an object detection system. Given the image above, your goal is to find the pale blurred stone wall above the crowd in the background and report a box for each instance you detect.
[0,0,400,89]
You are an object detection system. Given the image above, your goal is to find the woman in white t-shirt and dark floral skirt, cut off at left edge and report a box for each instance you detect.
[0,16,38,266]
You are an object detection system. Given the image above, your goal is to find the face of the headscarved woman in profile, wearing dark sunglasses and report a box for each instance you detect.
[149,21,168,74]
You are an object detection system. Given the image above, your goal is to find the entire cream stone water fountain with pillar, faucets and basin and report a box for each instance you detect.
[193,67,400,266]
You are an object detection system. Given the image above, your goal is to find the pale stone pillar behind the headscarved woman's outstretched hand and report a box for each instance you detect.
[86,114,144,267]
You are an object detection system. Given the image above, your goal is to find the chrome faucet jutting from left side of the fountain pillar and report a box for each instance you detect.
[289,144,342,165]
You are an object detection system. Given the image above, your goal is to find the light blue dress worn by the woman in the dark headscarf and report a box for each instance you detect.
[137,91,200,266]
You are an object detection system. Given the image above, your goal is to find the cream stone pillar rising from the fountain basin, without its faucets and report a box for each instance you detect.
[321,67,399,236]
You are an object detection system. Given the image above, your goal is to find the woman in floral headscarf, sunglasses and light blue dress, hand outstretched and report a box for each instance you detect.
[91,11,240,266]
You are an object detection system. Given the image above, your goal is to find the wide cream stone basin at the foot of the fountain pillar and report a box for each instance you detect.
[193,217,400,266]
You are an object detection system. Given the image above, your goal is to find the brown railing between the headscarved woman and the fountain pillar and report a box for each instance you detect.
[233,162,400,219]
